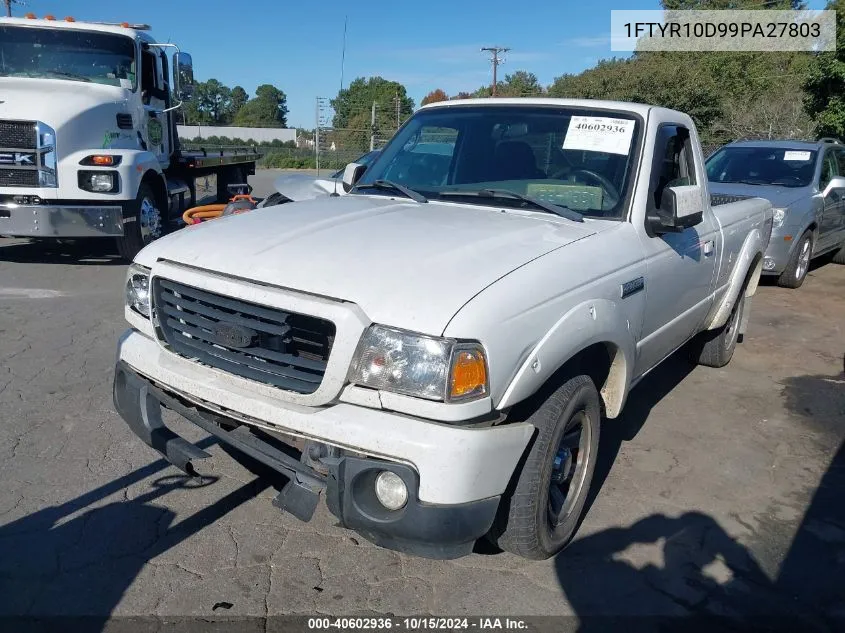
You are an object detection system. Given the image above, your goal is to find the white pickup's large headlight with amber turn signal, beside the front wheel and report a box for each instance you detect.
[349,325,489,402]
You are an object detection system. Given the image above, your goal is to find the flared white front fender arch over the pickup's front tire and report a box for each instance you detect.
[496,299,636,418]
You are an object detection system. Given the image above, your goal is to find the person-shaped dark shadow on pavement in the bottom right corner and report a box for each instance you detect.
[555,372,845,633]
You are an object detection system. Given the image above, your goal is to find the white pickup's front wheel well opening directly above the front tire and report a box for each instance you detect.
[508,341,627,418]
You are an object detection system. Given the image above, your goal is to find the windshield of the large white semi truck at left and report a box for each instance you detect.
[0,26,136,90]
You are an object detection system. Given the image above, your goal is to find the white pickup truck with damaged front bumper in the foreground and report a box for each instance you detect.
[114,99,772,559]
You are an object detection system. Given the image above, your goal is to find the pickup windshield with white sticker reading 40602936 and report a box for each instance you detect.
[355,105,640,219]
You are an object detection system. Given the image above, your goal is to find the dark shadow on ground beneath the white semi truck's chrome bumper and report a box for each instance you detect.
[0,238,126,266]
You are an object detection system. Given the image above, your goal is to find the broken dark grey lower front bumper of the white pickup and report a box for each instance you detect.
[114,361,500,559]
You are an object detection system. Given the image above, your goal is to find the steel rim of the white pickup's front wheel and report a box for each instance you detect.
[547,411,592,531]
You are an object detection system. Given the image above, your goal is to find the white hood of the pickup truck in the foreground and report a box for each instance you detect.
[136,194,604,334]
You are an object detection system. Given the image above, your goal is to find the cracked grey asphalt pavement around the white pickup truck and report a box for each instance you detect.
[0,171,845,630]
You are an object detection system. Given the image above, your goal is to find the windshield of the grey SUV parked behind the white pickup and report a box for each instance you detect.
[707,147,817,187]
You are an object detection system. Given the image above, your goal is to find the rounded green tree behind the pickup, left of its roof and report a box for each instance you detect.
[331,77,414,132]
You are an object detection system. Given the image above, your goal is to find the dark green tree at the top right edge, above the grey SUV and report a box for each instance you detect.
[804,0,845,138]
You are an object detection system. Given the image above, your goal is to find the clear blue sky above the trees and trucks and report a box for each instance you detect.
[21,0,825,128]
